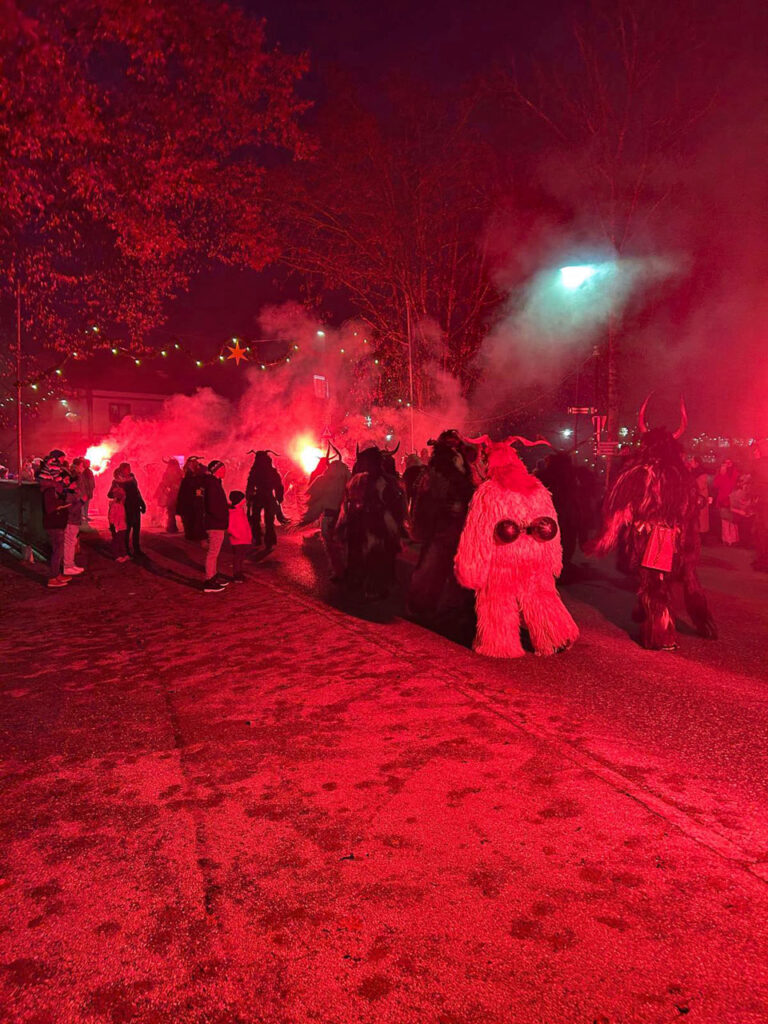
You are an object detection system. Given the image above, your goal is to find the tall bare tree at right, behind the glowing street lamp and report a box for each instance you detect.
[497,0,707,452]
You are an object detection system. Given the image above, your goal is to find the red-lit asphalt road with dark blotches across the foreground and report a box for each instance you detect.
[0,535,768,1024]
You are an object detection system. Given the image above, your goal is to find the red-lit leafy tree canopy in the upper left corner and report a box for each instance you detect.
[0,0,306,352]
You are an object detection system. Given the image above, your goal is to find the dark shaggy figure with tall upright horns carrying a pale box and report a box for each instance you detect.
[594,395,717,650]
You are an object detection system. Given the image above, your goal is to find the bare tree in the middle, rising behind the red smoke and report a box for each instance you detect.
[274,75,499,404]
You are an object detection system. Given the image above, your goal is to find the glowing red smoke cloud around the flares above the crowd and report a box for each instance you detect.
[83,303,468,494]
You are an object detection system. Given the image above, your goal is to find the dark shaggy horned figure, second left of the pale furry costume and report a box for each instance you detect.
[336,447,404,597]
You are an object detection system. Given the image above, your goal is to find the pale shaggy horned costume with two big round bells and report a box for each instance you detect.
[455,436,579,657]
